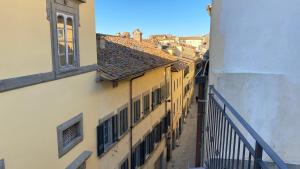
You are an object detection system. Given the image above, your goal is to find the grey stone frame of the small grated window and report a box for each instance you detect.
[57,113,83,158]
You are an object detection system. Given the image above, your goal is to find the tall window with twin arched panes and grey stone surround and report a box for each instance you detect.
[47,0,84,74]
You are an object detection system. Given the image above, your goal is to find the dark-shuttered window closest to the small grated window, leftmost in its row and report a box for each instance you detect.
[97,115,118,156]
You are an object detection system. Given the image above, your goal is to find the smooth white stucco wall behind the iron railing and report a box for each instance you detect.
[209,0,300,164]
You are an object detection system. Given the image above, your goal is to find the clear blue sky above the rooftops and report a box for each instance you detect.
[95,0,210,37]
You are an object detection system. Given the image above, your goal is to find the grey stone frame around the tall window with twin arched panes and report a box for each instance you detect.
[47,0,81,76]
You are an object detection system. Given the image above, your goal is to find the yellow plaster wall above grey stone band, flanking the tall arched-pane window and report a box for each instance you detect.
[0,0,97,79]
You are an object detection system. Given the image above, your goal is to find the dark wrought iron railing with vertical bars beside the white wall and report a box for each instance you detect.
[204,86,288,169]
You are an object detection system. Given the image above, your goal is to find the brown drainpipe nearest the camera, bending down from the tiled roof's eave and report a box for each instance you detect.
[128,73,144,168]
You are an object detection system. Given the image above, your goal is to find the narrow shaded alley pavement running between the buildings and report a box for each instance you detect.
[167,85,198,169]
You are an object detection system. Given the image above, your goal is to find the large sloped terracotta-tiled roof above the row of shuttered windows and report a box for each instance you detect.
[97,34,176,81]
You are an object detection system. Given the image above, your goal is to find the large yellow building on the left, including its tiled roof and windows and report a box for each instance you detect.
[0,0,197,169]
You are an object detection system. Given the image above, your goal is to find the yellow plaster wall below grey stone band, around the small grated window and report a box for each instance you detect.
[0,72,129,169]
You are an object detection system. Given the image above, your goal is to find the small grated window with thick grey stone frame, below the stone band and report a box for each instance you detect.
[57,113,83,157]
